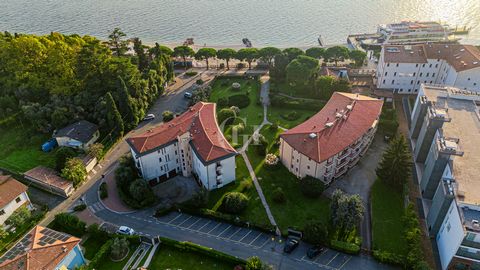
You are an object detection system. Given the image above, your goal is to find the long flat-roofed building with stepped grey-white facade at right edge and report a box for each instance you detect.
[410,84,480,269]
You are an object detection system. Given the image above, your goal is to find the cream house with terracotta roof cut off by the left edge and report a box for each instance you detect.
[0,175,33,225]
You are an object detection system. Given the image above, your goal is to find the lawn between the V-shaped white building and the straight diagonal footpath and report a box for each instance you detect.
[207,155,269,225]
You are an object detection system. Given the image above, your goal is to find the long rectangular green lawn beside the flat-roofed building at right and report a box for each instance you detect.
[371,179,407,254]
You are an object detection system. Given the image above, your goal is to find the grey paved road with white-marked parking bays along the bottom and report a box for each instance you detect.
[84,178,392,270]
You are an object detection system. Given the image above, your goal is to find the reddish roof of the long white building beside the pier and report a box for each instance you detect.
[383,44,480,71]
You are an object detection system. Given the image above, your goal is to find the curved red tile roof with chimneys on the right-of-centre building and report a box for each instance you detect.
[281,92,383,163]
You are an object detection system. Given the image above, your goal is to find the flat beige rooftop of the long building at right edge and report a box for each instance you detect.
[424,85,480,205]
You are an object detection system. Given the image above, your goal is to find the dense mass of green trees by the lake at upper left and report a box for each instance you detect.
[0,29,173,139]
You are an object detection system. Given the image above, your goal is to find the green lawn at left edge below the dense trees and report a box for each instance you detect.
[0,125,55,173]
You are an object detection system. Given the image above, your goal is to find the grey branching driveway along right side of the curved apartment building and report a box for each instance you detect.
[325,134,387,250]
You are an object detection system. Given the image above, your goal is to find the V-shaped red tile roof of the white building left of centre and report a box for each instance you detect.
[127,102,237,163]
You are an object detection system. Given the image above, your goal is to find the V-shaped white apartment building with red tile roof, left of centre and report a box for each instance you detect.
[127,102,237,190]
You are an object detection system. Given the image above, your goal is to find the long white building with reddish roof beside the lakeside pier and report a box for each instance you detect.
[376,44,480,94]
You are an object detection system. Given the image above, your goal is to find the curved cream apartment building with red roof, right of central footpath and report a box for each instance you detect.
[280,92,383,184]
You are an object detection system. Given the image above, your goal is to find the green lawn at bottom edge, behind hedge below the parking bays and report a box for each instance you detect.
[149,245,235,270]
